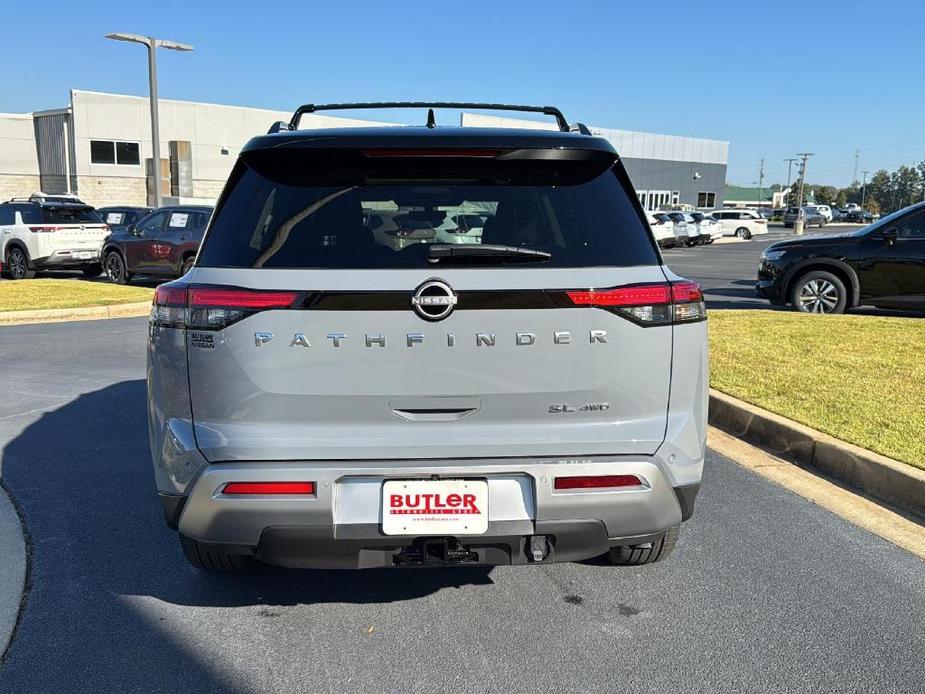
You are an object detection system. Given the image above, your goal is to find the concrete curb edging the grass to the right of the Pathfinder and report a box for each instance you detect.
[709,388,925,517]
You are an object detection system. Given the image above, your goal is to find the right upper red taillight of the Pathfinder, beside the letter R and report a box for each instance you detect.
[566,280,707,327]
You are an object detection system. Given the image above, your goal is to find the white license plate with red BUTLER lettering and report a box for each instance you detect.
[382,480,488,535]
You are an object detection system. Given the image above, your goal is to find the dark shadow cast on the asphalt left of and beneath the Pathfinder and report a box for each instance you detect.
[0,380,492,691]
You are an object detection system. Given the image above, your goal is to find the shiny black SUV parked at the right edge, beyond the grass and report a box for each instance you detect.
[755,202,925,313]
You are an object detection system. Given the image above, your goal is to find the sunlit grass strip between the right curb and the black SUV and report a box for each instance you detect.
[709,311,925,468]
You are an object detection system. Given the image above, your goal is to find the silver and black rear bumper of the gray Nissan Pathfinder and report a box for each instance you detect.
[161,457,699,568]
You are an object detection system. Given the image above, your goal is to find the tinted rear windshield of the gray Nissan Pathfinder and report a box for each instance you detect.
[198,151,659,269]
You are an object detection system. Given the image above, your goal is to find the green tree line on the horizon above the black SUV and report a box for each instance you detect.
[788,161,925,214]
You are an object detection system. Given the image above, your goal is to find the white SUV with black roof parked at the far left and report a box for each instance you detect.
[0,193,109,280]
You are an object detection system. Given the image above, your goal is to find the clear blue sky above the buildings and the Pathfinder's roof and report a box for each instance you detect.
[0,0,925,185]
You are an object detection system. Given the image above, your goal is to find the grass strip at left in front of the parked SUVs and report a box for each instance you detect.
[0,279,154,311]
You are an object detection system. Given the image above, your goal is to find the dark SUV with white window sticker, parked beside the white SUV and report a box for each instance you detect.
[102,205,212,284]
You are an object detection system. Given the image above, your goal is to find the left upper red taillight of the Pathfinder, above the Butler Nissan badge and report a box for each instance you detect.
[151,284,299,330]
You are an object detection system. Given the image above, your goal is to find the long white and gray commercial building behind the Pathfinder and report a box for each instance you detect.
[0,90,729,209]
